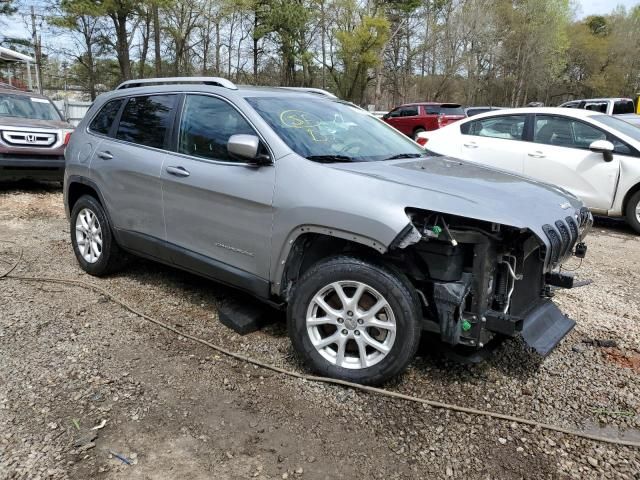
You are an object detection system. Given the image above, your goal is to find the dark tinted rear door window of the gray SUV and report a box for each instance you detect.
[116,95,176,148]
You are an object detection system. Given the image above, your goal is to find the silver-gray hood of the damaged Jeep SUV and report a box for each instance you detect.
[330,157,583,232]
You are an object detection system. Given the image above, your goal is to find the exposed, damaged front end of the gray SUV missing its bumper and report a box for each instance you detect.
[390,209,593,356]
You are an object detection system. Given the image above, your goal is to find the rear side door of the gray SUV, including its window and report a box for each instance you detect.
[91,94,177,244]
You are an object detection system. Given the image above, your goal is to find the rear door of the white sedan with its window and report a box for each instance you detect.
[458,114,528,174]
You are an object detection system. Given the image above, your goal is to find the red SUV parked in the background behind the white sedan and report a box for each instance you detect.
[382,102,466,140]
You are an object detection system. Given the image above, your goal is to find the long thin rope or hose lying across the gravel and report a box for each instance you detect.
[0,240,640,448]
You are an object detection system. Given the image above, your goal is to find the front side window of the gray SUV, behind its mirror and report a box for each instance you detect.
[178,95,256,162]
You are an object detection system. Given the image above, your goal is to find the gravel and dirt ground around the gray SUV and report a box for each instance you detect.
[0,183,640,480]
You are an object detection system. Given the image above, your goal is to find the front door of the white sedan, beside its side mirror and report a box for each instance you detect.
[524,115,624,211]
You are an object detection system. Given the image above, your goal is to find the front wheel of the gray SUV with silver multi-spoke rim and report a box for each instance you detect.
[287,256,421,385]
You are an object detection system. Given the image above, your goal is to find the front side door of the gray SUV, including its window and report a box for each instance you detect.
[162,94,275,287]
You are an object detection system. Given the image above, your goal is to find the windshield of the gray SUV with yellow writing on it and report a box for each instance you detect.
[247,97,425,162]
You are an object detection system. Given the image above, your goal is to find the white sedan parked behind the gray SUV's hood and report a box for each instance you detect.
[418,108,640,233]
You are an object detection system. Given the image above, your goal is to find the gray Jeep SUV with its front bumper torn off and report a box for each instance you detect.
[64,77,592,384]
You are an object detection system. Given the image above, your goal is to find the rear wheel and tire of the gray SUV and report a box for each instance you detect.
[69,195,127,277]
